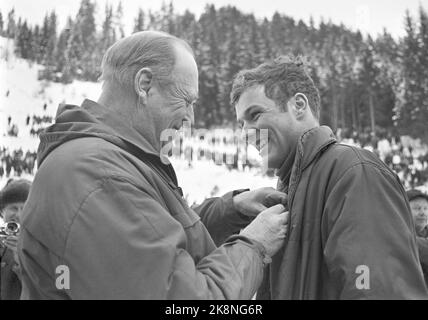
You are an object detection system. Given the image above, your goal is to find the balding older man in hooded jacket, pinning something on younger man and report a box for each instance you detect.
[18,31,287,299]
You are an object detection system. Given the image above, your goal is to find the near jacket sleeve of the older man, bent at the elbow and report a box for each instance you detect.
[64,178,263,299]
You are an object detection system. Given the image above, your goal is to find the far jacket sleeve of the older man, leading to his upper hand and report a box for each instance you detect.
[193,191,254,246]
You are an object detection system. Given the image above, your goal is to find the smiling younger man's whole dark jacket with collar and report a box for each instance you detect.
[258,126,428,299]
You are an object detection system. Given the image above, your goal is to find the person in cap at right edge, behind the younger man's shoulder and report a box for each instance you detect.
[407,189,428,286]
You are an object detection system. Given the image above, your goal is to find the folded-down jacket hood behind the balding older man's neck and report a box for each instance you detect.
[37,99,164,167]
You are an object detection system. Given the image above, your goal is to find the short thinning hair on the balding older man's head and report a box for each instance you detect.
[100,31,193,89]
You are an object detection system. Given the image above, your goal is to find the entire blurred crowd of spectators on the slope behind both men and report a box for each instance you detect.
[0,115,428,189]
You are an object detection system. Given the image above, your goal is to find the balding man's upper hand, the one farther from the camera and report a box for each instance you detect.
[233,187,287,217]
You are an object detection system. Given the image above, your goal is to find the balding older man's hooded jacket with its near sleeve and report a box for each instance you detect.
[18,100,263,299]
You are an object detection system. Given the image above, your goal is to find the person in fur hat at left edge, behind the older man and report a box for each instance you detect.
[0,179,31,300]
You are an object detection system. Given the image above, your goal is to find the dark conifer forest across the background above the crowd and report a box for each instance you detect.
[0,0,428,141]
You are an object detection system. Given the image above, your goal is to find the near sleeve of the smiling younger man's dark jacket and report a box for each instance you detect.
[323,163,428,299]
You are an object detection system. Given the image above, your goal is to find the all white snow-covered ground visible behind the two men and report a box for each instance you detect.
[0,38,276,204]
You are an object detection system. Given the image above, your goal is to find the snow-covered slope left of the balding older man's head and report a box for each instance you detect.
[0,37,101,151]
